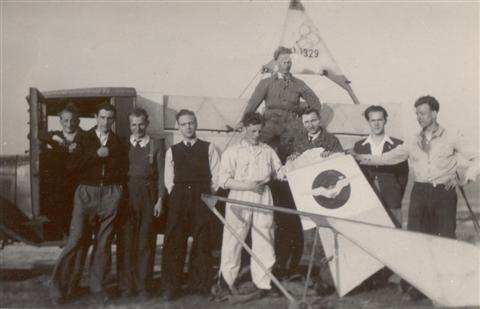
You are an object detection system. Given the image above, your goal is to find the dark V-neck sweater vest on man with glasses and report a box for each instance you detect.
[172,139,212,184]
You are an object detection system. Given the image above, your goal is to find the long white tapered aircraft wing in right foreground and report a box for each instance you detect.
[202,195,480,307]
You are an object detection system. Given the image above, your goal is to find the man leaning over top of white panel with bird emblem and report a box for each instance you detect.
[288,108,343,295]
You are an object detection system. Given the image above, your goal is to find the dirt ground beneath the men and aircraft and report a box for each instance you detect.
[0,212,480,309]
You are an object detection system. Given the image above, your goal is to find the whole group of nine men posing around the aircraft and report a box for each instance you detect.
[44,49,478,303]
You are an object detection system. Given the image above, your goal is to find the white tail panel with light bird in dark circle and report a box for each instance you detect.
[287,150,394,296]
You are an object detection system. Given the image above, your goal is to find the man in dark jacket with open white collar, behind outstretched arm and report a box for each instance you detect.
[354,105,408,227]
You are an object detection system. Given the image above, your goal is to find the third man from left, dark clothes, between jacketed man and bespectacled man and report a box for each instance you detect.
[117,108,165,299]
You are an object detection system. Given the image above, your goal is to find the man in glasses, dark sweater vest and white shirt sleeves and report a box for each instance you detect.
[162,110,220,300]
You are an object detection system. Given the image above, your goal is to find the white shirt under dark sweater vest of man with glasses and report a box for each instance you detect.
[164,138,220,193]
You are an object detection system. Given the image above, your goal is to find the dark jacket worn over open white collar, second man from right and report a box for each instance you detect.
[353,137,408,209]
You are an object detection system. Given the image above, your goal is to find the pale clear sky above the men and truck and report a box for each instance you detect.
[0,1,480,154]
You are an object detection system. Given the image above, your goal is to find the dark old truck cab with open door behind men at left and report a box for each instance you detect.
[0,87,136,246]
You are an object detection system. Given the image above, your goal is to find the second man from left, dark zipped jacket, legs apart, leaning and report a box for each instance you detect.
[51,102,126,303]
